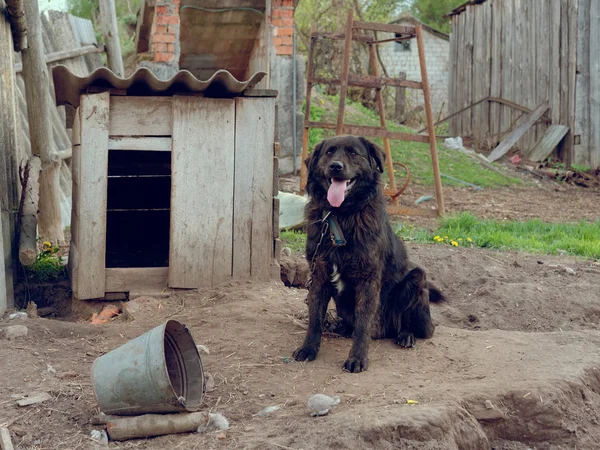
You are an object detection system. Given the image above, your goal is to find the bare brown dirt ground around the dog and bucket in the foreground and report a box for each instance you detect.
[0,241,600,450]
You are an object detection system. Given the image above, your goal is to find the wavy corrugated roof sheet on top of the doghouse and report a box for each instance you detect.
[52,65,266,107]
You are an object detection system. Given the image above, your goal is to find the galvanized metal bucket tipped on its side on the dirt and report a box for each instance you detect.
[92,320,204,415]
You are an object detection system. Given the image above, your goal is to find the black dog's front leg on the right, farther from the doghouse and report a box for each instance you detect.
[344,280,381,372]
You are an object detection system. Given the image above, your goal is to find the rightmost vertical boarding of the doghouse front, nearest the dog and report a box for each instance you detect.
[233,98,275,280]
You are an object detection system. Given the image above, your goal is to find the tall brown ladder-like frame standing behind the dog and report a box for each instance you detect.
[300,10,445,216]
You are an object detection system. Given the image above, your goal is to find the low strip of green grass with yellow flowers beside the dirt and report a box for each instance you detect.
[281,213,600,259]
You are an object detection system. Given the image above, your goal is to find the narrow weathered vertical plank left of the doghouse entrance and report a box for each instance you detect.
[73,92,110,300]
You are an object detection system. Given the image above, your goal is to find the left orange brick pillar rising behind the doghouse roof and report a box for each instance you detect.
[150,0,181,65]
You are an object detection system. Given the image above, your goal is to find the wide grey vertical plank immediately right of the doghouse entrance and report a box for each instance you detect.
[169,96,236,288]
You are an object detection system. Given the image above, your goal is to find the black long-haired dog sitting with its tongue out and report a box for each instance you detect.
[294,136,445,372]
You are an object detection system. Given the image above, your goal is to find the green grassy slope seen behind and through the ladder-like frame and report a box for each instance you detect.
[308,94,521,188]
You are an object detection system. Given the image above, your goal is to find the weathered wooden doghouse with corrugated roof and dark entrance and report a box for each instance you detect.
[53,66,279,299]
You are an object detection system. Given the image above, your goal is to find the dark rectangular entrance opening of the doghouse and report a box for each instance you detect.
[106,150,171,268]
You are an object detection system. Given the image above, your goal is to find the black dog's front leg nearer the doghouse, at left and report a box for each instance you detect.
[293,260,333,361]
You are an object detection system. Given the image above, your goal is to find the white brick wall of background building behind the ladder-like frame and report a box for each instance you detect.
[379,22,450,120]
